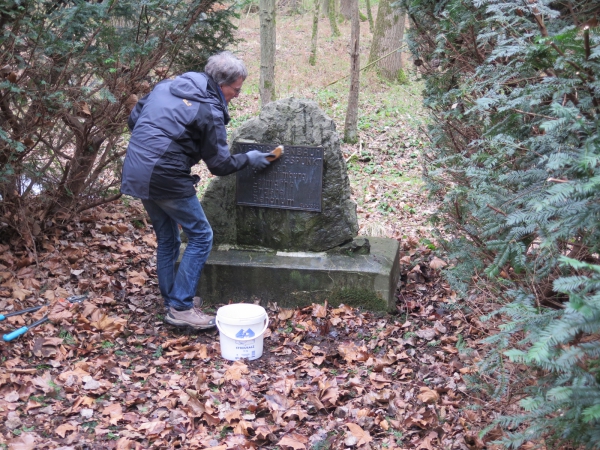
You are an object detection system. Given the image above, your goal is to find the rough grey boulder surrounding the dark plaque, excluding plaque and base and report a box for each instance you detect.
[202,98,358,252]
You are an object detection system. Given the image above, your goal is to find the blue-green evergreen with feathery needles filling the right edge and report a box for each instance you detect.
[402,0,600,449]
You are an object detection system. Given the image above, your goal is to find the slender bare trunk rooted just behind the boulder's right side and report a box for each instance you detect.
[344,0,360,143]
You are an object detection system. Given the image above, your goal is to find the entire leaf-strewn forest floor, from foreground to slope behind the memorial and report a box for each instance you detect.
[0,7,506,450]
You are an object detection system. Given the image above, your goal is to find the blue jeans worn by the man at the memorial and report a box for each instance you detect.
[142,196,213,311]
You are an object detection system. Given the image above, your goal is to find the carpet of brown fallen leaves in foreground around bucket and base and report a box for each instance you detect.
[0,200,492,450]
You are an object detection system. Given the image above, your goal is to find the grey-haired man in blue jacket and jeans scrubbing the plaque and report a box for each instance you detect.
[121,51,269,329]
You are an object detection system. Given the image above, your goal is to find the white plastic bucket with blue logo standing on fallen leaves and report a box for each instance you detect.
[215,303,269,361]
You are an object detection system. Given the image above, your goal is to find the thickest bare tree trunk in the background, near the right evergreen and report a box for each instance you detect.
[369,0,406,81]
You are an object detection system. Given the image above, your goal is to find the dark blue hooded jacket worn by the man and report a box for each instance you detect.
[121,72,248,200]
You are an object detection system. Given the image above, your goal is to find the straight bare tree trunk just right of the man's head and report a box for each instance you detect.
[259,0,277,106]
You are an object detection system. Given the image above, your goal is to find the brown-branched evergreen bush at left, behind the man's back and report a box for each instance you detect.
[0,0,234,244]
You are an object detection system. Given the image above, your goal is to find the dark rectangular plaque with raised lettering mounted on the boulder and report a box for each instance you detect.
[236,143,323,212]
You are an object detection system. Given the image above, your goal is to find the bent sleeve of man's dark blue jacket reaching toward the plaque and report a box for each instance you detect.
[199,104,248,176]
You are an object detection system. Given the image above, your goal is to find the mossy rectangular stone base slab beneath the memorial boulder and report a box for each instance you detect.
[192,237,400,311]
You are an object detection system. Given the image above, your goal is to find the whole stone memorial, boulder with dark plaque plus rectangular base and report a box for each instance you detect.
[198,98,399,310]
